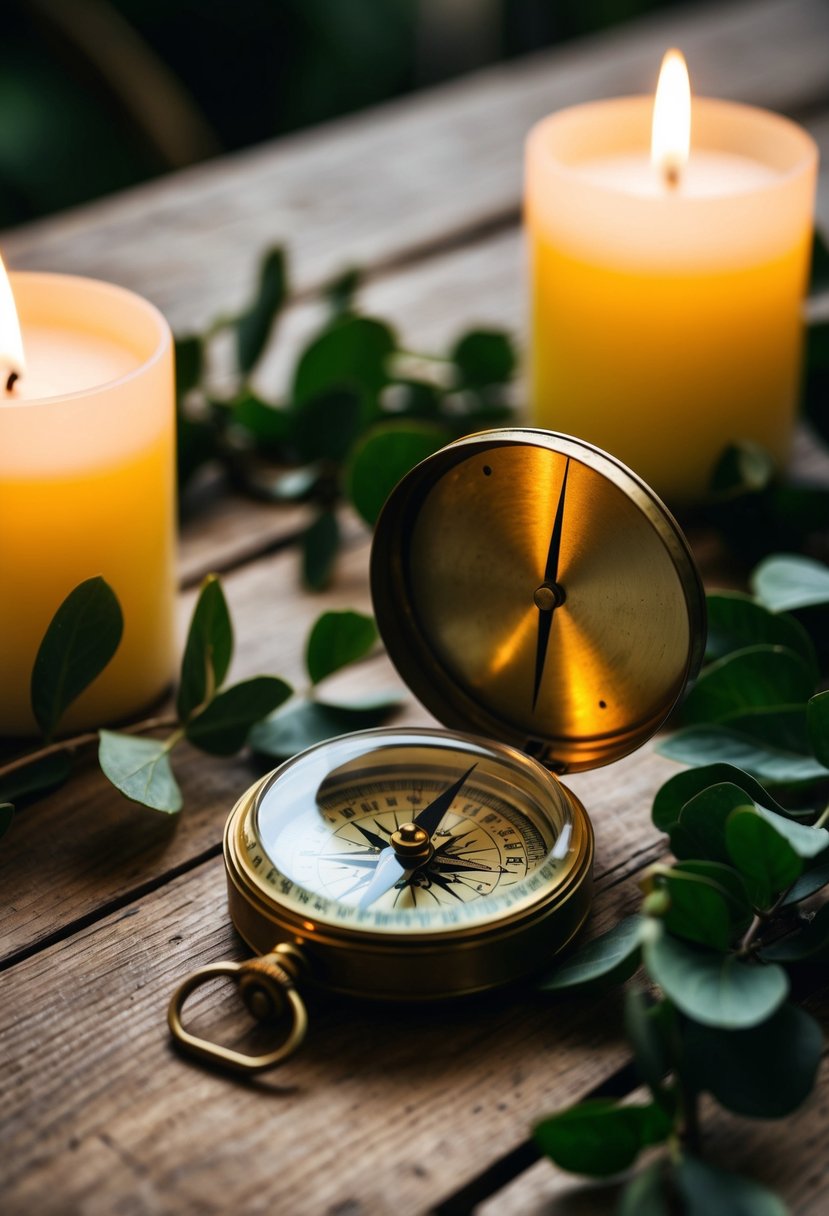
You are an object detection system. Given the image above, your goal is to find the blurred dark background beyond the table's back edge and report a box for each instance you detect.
[0,0,670,226]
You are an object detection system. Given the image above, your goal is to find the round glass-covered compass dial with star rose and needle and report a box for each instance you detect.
[244,731,574,933]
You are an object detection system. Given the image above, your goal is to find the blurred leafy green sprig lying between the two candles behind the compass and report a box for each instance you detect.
[176,249,517,589]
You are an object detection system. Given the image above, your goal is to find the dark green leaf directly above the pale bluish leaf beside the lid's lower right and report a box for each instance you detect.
[682,646,814,724]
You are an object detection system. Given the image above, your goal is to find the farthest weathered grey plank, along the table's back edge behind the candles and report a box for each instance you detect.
[2,0,829,328]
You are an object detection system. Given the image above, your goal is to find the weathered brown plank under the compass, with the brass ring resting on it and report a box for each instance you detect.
[0,778,666,1216]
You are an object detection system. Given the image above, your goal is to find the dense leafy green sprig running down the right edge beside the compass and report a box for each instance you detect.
[535,556,829,1216]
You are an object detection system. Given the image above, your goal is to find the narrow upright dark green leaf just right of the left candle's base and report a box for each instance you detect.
[176,574,233,722]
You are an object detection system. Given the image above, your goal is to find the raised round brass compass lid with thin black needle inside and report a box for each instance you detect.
[371,428,705,772]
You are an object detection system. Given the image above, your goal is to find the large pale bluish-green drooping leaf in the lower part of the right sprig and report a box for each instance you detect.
[644,933,789,1030]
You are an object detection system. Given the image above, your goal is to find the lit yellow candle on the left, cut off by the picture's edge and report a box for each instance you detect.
[0,264,175,734]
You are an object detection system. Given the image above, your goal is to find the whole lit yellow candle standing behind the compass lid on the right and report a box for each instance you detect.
[526,52,817,503]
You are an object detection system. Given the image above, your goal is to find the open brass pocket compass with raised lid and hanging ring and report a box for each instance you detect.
[169,429,705,1070]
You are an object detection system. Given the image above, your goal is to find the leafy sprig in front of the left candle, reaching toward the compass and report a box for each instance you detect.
[0,575,399,835]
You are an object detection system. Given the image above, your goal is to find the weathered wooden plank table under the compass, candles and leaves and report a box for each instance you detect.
[0,0,829,1216]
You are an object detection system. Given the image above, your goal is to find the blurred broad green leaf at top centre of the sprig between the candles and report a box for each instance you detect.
[291,314,397,408]
